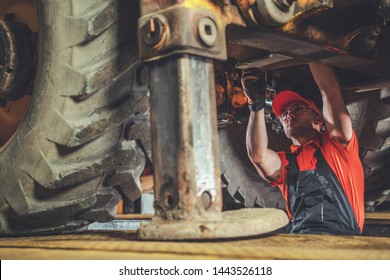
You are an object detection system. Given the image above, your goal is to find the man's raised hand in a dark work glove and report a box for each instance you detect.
[241,68,266,112]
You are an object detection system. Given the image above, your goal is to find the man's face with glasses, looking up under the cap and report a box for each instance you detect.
[279,102,316,139]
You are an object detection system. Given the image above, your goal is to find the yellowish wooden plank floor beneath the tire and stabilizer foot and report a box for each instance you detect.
[0,231,390,260]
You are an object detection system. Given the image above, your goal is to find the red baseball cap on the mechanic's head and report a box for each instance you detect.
[272,90,321,117]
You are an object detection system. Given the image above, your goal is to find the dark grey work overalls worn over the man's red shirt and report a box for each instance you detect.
[286,149,360,235]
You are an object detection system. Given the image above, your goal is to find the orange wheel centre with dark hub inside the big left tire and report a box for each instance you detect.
[0,0,38,148]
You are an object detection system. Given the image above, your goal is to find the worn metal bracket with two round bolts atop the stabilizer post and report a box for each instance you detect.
[138,5,227,62]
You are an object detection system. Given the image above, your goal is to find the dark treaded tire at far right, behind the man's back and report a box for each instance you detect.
[346,88,390,211]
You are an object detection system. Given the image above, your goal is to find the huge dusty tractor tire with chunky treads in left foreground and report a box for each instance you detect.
[0,0,150,235]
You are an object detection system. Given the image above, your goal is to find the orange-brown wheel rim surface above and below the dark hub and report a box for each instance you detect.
[0,0,38,149]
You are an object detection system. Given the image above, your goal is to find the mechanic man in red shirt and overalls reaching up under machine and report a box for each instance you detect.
[241,63,364,235]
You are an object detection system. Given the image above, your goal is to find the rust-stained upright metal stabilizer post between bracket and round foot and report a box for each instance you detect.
[145,56,221,223]
